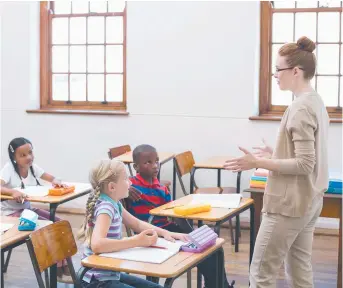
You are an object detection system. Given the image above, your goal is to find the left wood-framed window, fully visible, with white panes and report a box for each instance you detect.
[40,0,126,111]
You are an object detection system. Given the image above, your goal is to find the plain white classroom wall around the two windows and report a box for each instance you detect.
[0,1,342,227]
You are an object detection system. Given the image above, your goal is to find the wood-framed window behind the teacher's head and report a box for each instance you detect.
[260,1,343,122]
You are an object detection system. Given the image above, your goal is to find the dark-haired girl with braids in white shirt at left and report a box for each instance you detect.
[0,137,70,277]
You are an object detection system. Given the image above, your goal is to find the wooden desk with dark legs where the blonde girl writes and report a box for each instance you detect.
[78,238,225,288]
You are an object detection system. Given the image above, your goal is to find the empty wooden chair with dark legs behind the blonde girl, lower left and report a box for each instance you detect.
[27,220,81,288]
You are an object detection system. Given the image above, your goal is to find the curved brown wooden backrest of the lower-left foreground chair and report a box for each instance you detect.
[30,220,77,272]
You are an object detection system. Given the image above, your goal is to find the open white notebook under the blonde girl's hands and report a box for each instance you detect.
[99,238,185,264]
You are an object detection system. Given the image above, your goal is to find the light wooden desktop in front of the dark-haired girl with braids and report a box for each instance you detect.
[0,184,92,204]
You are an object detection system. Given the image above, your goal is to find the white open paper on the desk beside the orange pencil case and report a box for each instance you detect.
[189,194,242,209]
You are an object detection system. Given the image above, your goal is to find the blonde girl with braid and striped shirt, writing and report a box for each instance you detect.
[78,160,187,288]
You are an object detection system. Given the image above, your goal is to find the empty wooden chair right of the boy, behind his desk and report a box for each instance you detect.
[174,151,238,245]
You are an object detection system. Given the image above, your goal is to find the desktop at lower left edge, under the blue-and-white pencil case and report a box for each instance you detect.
[0,216,52,249]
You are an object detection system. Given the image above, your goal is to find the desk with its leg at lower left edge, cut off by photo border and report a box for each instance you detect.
[0,216,52,288]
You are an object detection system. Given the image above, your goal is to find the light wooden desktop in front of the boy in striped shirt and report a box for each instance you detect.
[150,195,254,222]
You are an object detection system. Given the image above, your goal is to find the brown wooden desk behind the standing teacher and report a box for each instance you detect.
[244,188,342,288]
